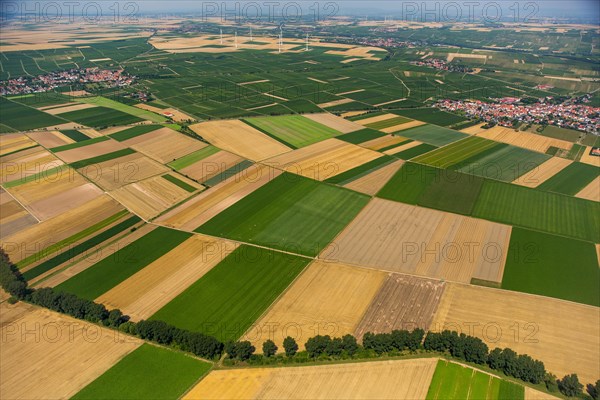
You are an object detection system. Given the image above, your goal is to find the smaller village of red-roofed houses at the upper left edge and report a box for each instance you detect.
[0,67,135,96]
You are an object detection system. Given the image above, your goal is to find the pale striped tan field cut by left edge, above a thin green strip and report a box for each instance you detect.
[0,146,64,184]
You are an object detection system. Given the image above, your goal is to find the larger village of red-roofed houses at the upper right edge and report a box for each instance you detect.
[436,95,600,134]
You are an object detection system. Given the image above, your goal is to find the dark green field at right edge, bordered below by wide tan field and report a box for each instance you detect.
[502,228,600,307]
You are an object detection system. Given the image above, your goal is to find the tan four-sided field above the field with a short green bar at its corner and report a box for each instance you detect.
[79,152,169,190]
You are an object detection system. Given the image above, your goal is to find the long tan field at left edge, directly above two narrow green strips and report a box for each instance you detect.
[0,195,123,263]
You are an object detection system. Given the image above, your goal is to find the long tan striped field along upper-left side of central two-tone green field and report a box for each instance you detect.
[155,164,282,231]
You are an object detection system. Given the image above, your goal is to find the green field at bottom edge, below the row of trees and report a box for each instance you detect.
[72,344,212,400]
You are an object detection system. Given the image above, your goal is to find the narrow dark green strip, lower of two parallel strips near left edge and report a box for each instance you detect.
[23,216,141,280]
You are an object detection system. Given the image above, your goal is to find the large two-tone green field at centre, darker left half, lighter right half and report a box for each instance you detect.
[196,173,369,256]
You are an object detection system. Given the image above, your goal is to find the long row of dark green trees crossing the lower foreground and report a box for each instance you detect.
[0,249,600,399]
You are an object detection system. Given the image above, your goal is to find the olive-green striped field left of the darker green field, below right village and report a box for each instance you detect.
[413,136,500,168]
